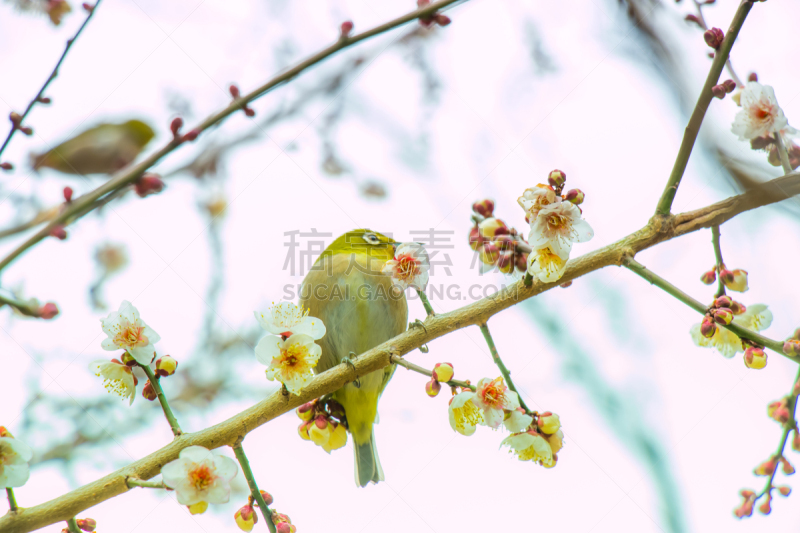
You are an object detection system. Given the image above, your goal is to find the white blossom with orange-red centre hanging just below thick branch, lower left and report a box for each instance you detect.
[161,446,239,505]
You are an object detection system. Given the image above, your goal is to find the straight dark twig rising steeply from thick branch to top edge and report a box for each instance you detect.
[656,0,753,215]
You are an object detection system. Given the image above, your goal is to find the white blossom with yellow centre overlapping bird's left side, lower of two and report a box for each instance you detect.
[256,333,322,394]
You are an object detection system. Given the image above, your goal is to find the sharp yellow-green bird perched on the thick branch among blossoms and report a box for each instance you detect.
[300,229,408,487]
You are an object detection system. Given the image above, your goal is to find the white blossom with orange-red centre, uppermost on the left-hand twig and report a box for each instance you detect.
[100,300,161,365]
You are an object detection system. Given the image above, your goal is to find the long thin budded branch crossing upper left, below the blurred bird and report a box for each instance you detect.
[0,0,464,270]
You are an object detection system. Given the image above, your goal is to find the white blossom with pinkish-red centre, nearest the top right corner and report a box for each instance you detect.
[731,81,787,141]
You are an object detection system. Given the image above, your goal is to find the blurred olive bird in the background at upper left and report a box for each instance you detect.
[31,120,155,175]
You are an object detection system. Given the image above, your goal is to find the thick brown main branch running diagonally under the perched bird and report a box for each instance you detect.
[0,172,800,533]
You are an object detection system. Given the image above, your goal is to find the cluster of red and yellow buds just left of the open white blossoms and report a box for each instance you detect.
[469,200,528,274]
